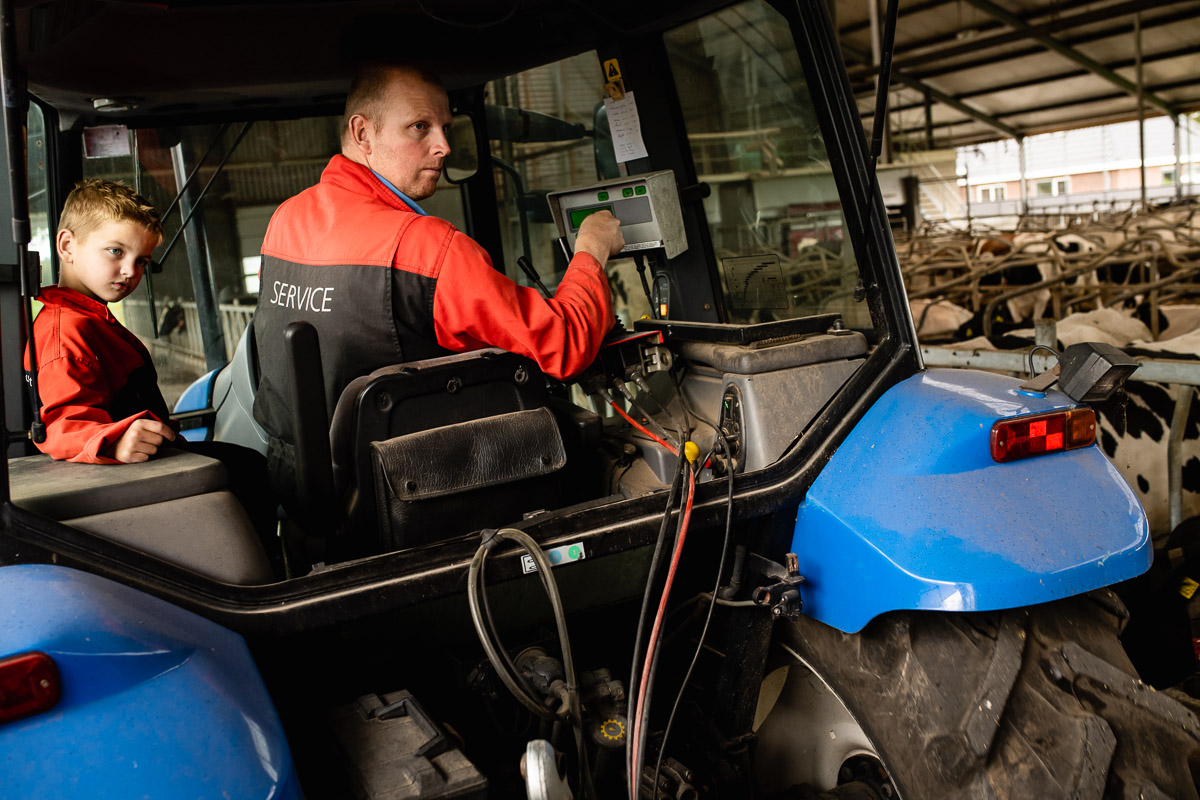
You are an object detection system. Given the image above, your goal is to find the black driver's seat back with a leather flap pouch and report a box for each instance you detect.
[330,349,565,551]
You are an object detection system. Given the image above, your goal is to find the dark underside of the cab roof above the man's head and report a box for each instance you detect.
[16,0,726,128]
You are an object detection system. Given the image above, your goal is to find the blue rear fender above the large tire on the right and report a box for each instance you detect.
[792,369,1152,632]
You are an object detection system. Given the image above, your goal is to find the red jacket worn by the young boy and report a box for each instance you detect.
[25,287,170,464]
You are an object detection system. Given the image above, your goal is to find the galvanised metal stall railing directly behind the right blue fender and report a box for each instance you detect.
[920,343,1200,530]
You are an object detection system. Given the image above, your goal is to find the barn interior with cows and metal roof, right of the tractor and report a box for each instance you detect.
[836,0,1200,679]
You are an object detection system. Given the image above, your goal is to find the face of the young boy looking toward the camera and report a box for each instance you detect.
[56,219,161,303]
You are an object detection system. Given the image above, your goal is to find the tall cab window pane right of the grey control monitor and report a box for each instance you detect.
[666,0,871,329]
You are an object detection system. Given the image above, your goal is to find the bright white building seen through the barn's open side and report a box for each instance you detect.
[958,116,1200,217]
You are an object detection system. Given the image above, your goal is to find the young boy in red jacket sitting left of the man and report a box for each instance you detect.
[25,179,278,565]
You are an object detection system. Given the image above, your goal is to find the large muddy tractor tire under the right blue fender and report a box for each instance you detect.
[758,589,1200,800]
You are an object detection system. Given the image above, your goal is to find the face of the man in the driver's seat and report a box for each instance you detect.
[366,73,452,200]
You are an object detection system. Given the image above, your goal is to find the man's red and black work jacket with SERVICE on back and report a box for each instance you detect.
[254,155,613,444]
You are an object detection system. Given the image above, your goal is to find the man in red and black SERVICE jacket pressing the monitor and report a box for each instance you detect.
[254,65,624,496]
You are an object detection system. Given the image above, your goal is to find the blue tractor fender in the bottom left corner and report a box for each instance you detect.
[0,565,302,800]
